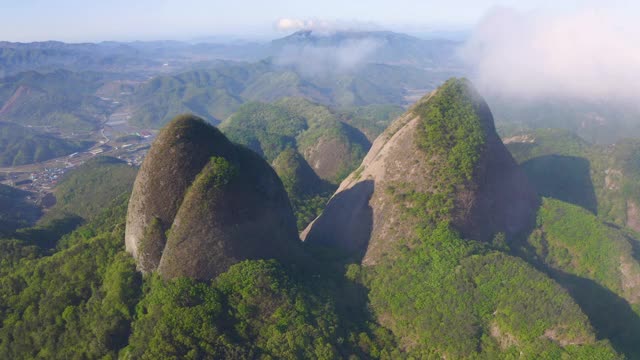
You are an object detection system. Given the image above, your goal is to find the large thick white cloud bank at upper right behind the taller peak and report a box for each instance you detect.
[460,7,640,100]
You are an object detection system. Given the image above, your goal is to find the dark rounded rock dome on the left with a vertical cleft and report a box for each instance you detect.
[125,115,300,279]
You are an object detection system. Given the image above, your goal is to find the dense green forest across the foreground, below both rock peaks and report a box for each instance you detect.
[0,190,618,359]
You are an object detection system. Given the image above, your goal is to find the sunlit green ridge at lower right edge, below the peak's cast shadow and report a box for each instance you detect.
[522,199,640,359]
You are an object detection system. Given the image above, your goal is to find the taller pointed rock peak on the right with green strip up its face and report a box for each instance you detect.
[302,79,538,264]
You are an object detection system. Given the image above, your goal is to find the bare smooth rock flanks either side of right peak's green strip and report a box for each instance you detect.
[301,83,539,265]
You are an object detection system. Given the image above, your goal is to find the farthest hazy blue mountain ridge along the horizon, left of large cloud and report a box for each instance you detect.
[0,31,458,77]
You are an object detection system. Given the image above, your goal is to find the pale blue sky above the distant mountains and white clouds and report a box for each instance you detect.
[0,0,631,42]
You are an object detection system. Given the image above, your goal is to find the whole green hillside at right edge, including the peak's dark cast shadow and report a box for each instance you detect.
[506,129,640,358]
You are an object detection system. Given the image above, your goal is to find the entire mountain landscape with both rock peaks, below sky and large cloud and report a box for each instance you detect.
[0,26,640,360]
